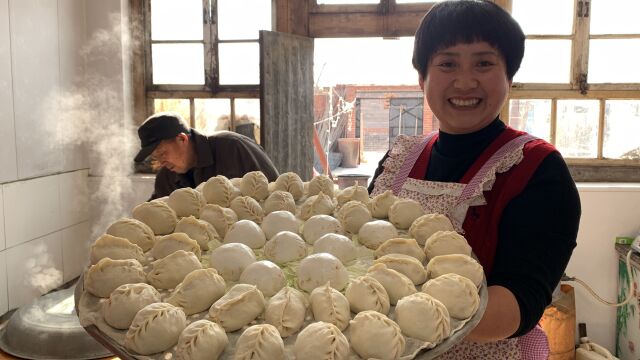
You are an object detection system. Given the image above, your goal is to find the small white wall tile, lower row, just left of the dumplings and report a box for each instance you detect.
[62,221,93,283]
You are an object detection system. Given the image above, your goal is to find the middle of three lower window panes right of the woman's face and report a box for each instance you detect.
[556,100,600,158]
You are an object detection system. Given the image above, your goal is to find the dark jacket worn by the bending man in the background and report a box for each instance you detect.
[151,129,278,199]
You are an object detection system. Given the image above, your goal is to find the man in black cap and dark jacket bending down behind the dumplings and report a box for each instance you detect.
[135,112,278,200]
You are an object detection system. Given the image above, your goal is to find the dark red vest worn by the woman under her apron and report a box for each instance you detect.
[409,127,556,276]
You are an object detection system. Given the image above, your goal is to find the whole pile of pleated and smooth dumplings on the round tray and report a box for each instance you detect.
[84,171,483,360]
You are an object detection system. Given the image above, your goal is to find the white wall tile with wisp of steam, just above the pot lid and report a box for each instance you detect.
[5,231,63,309]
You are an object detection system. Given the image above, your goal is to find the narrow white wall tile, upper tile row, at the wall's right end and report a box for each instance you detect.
[58,170,89,227]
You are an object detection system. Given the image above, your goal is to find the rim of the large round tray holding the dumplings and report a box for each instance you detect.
[75,256,488,360]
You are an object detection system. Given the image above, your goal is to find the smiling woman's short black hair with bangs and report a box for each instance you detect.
[413,0,525,80]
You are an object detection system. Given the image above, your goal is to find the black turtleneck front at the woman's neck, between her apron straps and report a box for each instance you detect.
[425,118,506,182]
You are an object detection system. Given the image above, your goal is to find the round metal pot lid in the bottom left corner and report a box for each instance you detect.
[0,287,112,360]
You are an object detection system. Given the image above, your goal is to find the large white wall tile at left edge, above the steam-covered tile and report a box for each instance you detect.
[3,175,62,248]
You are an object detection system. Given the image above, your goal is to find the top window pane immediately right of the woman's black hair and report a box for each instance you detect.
[512,0,573,35]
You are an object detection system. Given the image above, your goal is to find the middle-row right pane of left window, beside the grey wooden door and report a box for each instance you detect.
[218,43,260,85]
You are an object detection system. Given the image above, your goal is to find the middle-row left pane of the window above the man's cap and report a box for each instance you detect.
[151,44,204,85]
